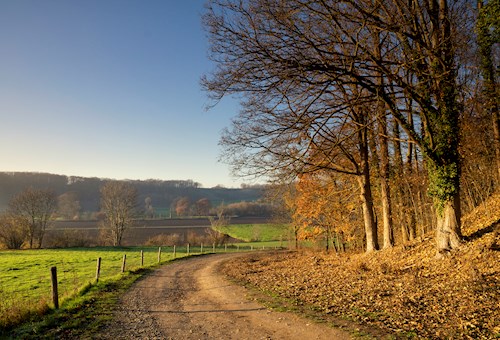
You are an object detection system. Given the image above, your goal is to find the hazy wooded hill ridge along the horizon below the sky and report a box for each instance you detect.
[0,172,263,212]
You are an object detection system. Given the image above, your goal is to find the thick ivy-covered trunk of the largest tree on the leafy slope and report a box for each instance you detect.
[425,0,461,254]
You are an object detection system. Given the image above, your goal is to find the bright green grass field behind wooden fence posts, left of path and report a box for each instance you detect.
[0,247,191,327]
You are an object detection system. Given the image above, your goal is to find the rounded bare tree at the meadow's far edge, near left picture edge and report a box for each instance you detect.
[7,188,57,248]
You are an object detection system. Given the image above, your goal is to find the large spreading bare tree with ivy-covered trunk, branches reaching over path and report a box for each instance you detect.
[203,0,467,253]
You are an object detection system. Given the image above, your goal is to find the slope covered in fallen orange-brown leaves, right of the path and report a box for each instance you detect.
[224,195,500,339]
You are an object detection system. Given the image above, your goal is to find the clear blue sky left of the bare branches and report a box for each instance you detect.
[0,0,241,187]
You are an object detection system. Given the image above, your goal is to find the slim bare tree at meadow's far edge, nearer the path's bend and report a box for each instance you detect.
[101,181,137,246]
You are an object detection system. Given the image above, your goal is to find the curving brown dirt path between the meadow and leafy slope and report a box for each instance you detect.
[96,254,350,340]
